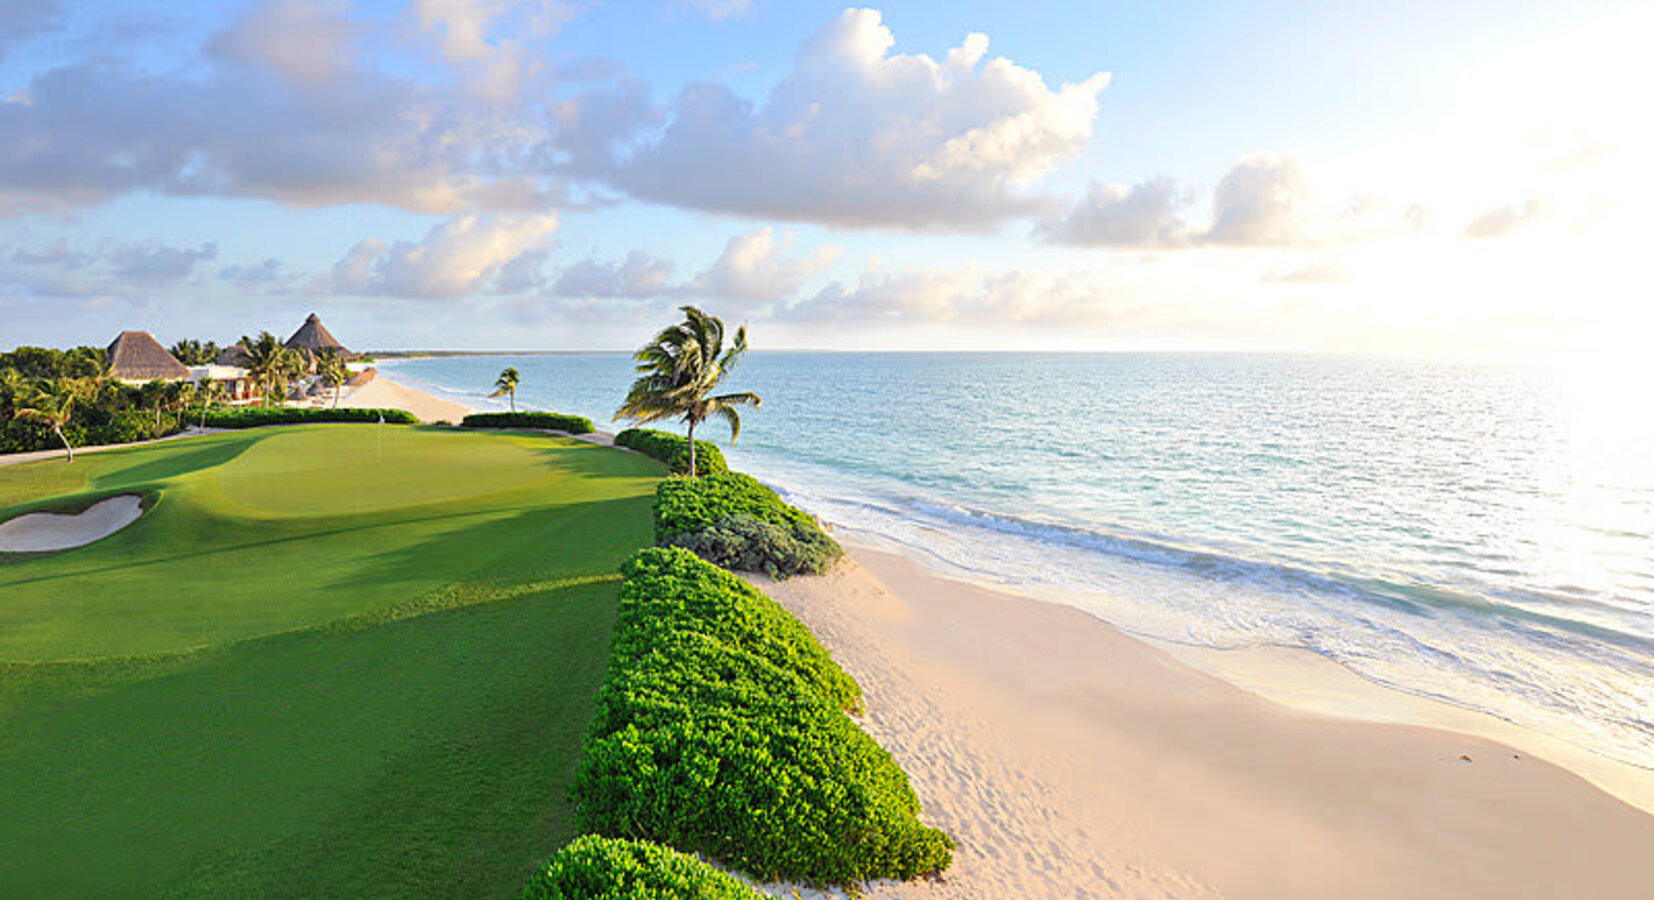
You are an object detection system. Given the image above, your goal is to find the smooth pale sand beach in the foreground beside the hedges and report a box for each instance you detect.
[758,548,1654,900]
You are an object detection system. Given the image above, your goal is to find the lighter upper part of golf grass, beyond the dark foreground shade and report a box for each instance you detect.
[0,425,660,662]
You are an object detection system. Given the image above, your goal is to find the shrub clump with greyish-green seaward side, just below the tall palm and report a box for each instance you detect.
[655,472,844,579]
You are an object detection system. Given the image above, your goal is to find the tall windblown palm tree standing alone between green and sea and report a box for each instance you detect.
[615,306,762,478]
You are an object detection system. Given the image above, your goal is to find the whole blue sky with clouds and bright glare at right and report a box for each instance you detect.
[0,0,1654,354]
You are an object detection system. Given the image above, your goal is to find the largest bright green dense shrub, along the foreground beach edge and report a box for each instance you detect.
[574,549,953,883]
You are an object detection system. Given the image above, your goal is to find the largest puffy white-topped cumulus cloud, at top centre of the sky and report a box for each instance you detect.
[586,10,1108,228]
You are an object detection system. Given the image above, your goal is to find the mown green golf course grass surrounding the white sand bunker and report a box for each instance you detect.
[0,425,665,898]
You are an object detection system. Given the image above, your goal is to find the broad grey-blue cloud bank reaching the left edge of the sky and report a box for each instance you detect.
[0,0,568,215]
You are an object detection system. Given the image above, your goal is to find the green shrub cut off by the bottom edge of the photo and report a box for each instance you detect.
[523,834,764,900]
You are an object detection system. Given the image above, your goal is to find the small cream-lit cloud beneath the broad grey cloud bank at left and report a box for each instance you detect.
[324,213,557,299]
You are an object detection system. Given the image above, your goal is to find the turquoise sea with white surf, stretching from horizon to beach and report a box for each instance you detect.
[387,352,1654,766]
